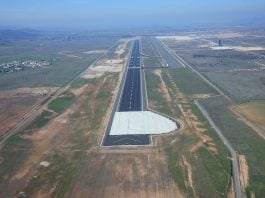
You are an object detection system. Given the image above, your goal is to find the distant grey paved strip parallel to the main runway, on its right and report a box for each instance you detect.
[150,38,181,68]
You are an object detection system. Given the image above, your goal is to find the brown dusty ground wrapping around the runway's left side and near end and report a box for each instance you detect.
[0,45,185,198]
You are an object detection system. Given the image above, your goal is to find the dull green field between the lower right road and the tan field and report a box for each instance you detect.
[201,97,265,198]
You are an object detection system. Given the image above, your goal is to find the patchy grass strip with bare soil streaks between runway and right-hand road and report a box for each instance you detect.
[146,68,231,197]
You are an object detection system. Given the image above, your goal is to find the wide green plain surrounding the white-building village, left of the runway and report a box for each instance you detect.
[0,34,119,90]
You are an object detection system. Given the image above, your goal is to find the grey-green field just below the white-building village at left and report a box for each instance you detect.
[0,56,96,90]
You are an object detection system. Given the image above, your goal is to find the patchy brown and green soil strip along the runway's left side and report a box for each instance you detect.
[0,72,118,197]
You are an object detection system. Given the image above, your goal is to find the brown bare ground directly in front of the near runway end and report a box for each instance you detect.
[69,148,182,198]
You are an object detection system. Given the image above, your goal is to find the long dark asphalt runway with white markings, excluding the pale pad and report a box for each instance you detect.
[103,40,150,146]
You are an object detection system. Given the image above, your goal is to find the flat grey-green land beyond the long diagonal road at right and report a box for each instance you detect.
[160,31,265,102]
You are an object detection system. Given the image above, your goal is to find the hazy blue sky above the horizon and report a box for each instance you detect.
[0,0,265,29]
